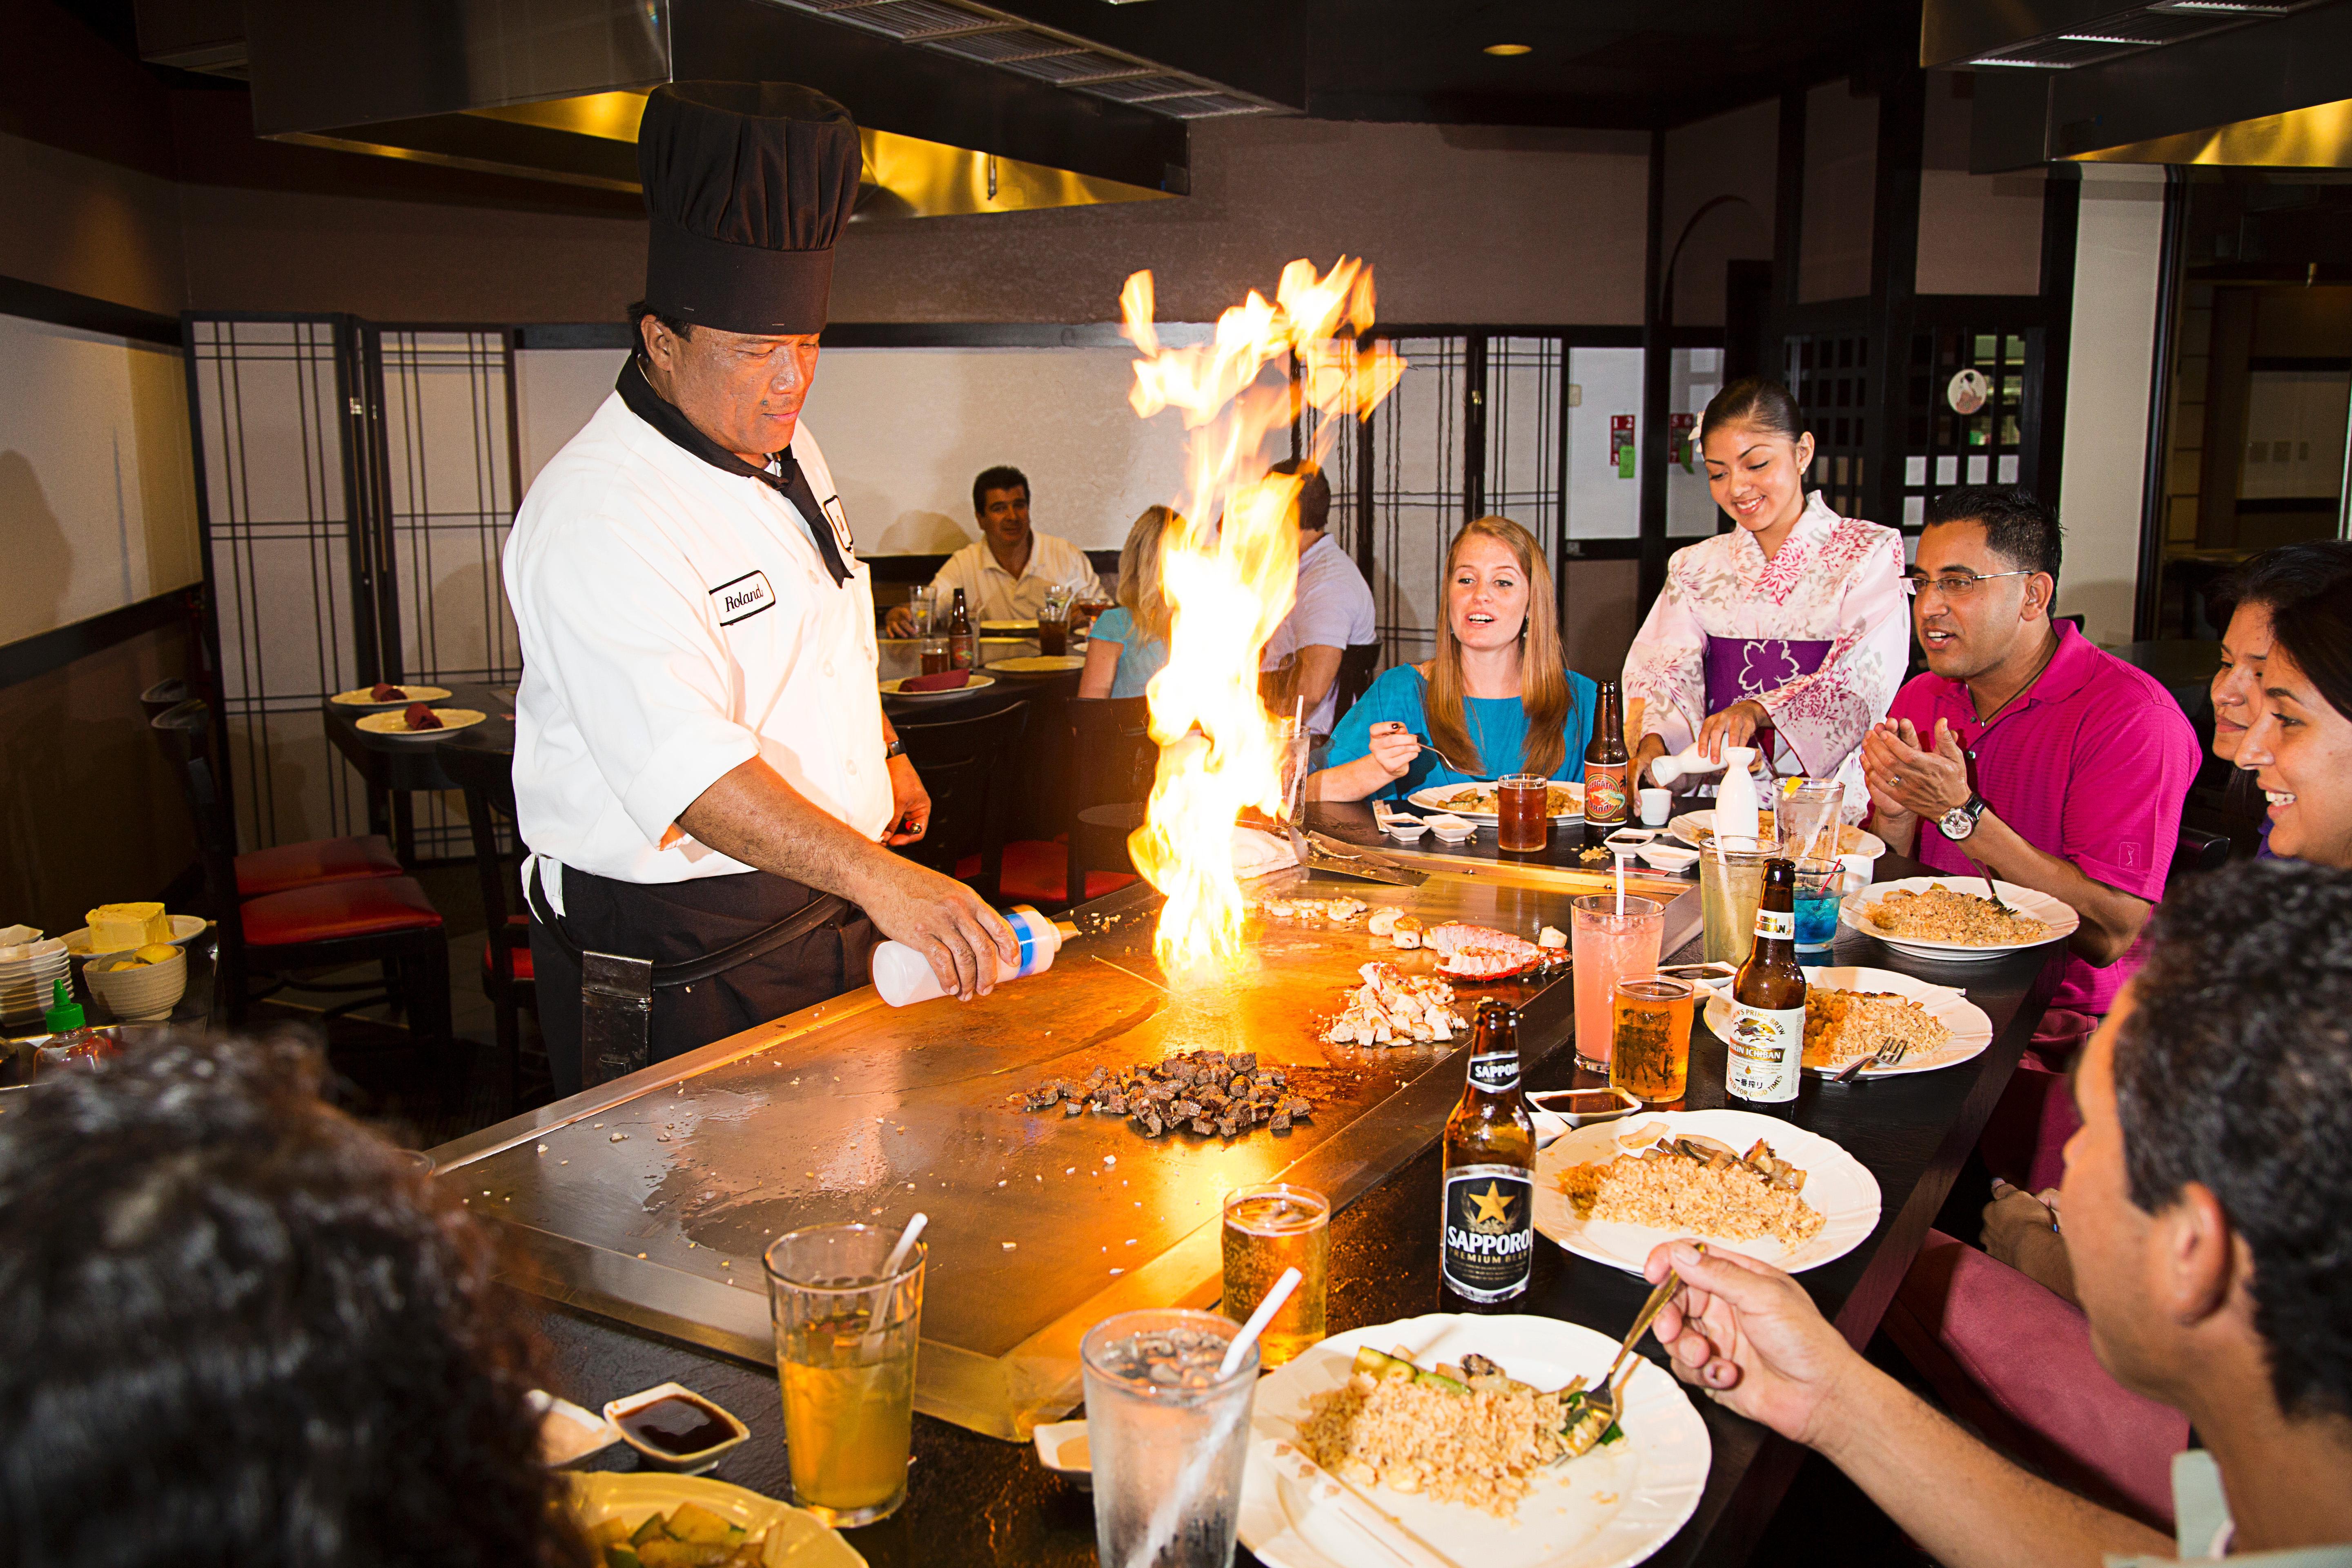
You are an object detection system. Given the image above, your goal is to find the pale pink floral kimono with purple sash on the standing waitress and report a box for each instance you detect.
[1625,491,1910,813]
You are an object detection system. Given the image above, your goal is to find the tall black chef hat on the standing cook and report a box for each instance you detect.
[637,82,861,334]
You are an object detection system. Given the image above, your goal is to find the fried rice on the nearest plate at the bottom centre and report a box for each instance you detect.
[1298,1373,1569,1519]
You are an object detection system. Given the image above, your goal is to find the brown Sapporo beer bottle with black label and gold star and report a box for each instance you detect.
[1439,1002,1536,1310]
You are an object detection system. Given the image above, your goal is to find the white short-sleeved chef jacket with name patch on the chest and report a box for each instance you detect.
[506,392,891,893]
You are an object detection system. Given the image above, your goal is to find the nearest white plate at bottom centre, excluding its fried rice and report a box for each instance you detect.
[1242,1312,1712,1568]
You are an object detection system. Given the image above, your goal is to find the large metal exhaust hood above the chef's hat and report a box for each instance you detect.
[139,0,1291,216]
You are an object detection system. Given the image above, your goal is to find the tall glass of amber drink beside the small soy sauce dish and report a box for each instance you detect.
[767,1225,929,1526]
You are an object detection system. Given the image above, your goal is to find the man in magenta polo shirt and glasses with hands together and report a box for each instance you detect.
[1863,484,2201,1189]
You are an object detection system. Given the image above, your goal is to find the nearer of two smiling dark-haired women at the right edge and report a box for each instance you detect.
[2232,583,2352,870]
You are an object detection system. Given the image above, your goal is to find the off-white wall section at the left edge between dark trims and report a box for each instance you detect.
[0,315,202,642]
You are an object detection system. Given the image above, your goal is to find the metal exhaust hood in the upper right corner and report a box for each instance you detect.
[1919,0,2352,174]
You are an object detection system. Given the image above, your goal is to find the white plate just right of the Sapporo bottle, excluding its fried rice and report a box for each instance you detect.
[1536,1109,1879,1274]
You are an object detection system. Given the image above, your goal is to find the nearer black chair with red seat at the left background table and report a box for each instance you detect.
[153,701,452,1067]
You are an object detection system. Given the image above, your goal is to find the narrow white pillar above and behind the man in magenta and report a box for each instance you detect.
[2058,165,2164,644]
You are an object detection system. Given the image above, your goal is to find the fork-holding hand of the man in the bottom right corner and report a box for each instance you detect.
[1642,1241,1865,1443]
